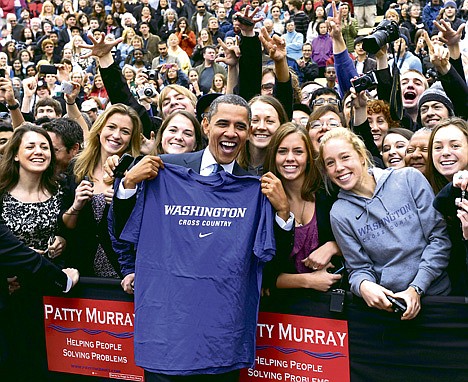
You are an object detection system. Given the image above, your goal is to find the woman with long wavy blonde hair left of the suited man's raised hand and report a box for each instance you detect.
[63,104,142,278]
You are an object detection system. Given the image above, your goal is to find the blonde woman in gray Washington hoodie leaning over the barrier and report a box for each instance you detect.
[318,128,450,320]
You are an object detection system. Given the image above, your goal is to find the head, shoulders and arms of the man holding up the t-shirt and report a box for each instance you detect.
[114,94,293,239]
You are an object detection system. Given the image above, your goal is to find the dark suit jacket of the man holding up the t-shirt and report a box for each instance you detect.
[113,150,294,255]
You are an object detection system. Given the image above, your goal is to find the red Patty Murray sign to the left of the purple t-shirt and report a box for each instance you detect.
[44,296,144,381]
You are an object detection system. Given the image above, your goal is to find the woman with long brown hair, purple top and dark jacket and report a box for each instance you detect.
[262,123,341,292]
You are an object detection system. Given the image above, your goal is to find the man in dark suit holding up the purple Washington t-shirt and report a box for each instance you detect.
[109,94,293,382]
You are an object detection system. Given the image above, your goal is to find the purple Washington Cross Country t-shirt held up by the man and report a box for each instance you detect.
[121,164,275,375]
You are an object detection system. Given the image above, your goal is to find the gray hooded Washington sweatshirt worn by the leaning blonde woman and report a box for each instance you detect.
[330,168,450,296]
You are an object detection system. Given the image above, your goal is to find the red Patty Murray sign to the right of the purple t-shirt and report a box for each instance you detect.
[240,312,350,382]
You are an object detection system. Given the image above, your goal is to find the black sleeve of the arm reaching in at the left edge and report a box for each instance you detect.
[0,219,67,292]
